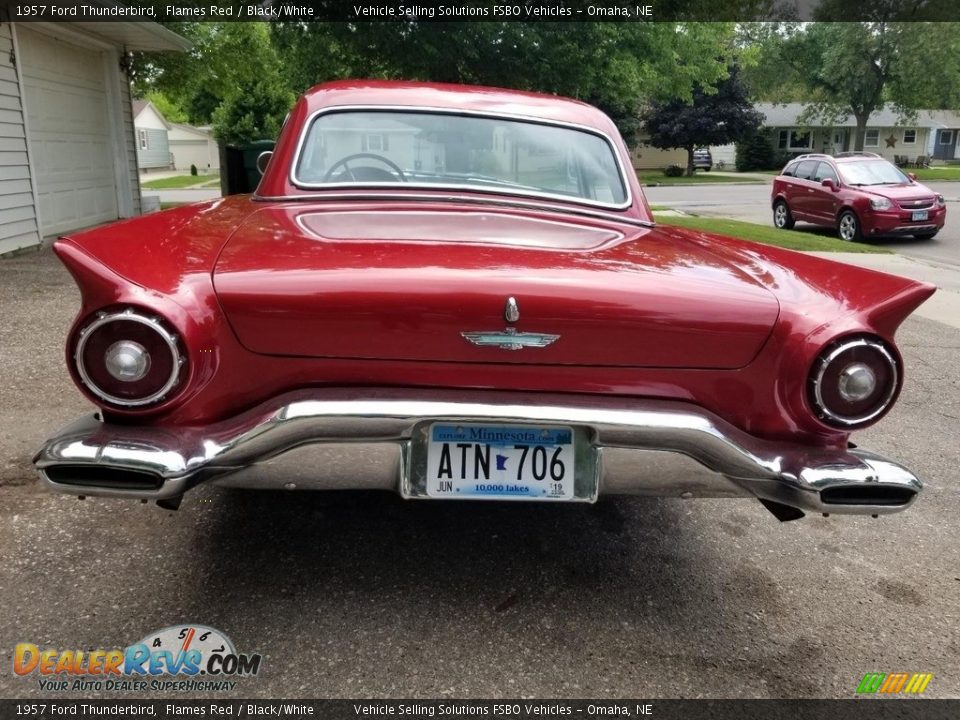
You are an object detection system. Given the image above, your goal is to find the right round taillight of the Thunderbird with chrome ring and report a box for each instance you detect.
[810,337,899,428]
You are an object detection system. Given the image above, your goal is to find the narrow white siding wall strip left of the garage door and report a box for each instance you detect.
[0,22,40,254]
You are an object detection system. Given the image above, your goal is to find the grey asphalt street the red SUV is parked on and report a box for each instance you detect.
[644,182,960,267]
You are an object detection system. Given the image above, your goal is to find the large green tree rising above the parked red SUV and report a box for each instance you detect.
[750,21,960,150]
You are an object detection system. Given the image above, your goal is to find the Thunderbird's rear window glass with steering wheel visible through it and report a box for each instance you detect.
[294,110,627,207]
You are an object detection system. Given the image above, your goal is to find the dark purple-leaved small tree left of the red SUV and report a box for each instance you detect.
[644,66,763,176]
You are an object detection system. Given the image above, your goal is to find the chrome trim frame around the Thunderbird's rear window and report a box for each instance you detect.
[288,104,633,210]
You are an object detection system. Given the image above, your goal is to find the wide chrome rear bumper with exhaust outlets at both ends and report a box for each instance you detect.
[34,390,923,514]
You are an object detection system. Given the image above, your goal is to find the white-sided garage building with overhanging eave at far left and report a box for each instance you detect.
[0,11,190,254]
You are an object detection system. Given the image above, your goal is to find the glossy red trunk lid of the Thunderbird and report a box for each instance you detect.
[214,203,779,368]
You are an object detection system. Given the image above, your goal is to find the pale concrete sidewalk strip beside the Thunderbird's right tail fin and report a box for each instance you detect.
[810,252,960,328]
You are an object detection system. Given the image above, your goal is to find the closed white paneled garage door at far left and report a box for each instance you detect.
[17,25,118,235]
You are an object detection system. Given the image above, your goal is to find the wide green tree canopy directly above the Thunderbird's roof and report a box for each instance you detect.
[271,20,736,139]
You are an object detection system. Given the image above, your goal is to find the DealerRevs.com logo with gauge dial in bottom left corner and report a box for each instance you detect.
[13,625,262,692]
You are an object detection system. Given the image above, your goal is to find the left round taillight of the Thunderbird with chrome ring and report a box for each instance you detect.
[74,309,185,407]
